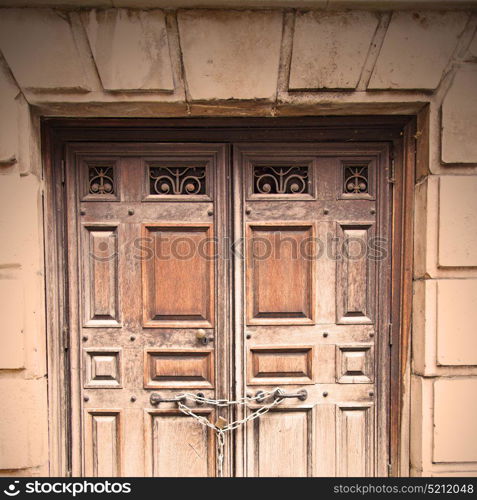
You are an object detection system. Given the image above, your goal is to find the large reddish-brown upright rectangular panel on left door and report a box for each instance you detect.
[142,223,215,328]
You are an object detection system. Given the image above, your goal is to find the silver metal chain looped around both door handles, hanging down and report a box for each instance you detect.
[176,388,283,477]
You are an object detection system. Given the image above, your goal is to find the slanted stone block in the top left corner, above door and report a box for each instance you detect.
[0,9,88,92]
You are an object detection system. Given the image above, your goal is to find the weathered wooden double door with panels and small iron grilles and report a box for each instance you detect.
[64,143,391,477]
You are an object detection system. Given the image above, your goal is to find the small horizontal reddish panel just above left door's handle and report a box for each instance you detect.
[144,349,215,389]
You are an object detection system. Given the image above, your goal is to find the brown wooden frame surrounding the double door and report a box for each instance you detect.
[41,115,416,476]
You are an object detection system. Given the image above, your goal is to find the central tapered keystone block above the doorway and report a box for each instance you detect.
[178,10,282,100]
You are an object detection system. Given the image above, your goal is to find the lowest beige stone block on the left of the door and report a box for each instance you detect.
[0,377,48,469]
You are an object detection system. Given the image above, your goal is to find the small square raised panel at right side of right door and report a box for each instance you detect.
[336,344,374,384]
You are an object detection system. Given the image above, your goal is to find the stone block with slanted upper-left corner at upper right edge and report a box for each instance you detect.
[442,64,477,163]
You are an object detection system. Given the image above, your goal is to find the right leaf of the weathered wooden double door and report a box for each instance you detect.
[234,144,389,476]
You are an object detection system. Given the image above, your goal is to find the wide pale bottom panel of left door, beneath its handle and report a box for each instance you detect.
[145,409,215,477]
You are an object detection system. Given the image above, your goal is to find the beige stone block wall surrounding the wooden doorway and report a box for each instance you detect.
[0,2,477,476]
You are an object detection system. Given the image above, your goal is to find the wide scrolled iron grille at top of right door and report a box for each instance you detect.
[253,166,309,194]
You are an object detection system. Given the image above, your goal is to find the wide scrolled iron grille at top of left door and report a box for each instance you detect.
[149,166,206,195]
